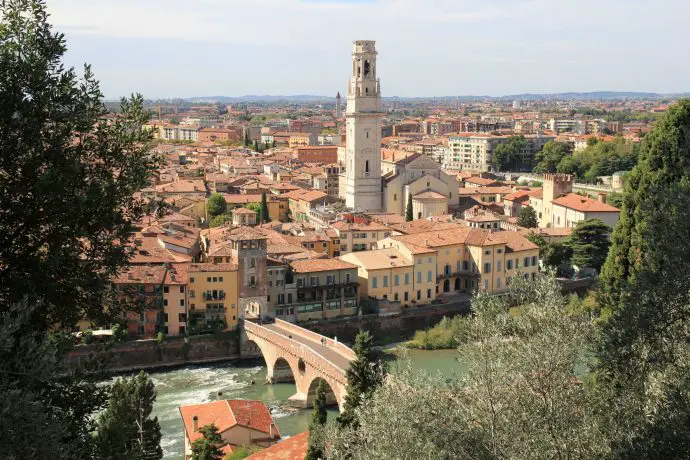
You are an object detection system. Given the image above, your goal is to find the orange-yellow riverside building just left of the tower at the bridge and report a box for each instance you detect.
[188,263,239,333]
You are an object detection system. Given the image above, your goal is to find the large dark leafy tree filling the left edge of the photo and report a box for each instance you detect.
[0,0,161,459]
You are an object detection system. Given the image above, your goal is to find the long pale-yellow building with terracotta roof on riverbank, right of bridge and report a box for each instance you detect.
[340,227,539,306]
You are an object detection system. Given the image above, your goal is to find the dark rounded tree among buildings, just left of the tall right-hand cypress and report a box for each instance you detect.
[566,218,611,271]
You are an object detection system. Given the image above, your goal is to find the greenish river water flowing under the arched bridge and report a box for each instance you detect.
[132,350,461,460]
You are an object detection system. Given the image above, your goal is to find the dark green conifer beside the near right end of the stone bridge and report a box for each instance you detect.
[338,331,384,427]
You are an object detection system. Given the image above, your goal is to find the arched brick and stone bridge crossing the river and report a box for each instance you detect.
[242,319,355,411]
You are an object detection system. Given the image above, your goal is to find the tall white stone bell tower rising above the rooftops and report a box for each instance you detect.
[344,40,383,212]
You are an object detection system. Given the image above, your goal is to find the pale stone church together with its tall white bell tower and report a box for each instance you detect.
[338,40,459,219]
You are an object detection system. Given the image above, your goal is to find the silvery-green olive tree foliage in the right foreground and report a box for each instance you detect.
[326,276,617,459]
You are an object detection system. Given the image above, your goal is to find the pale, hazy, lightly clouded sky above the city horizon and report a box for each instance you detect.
[47,0,690,99]
